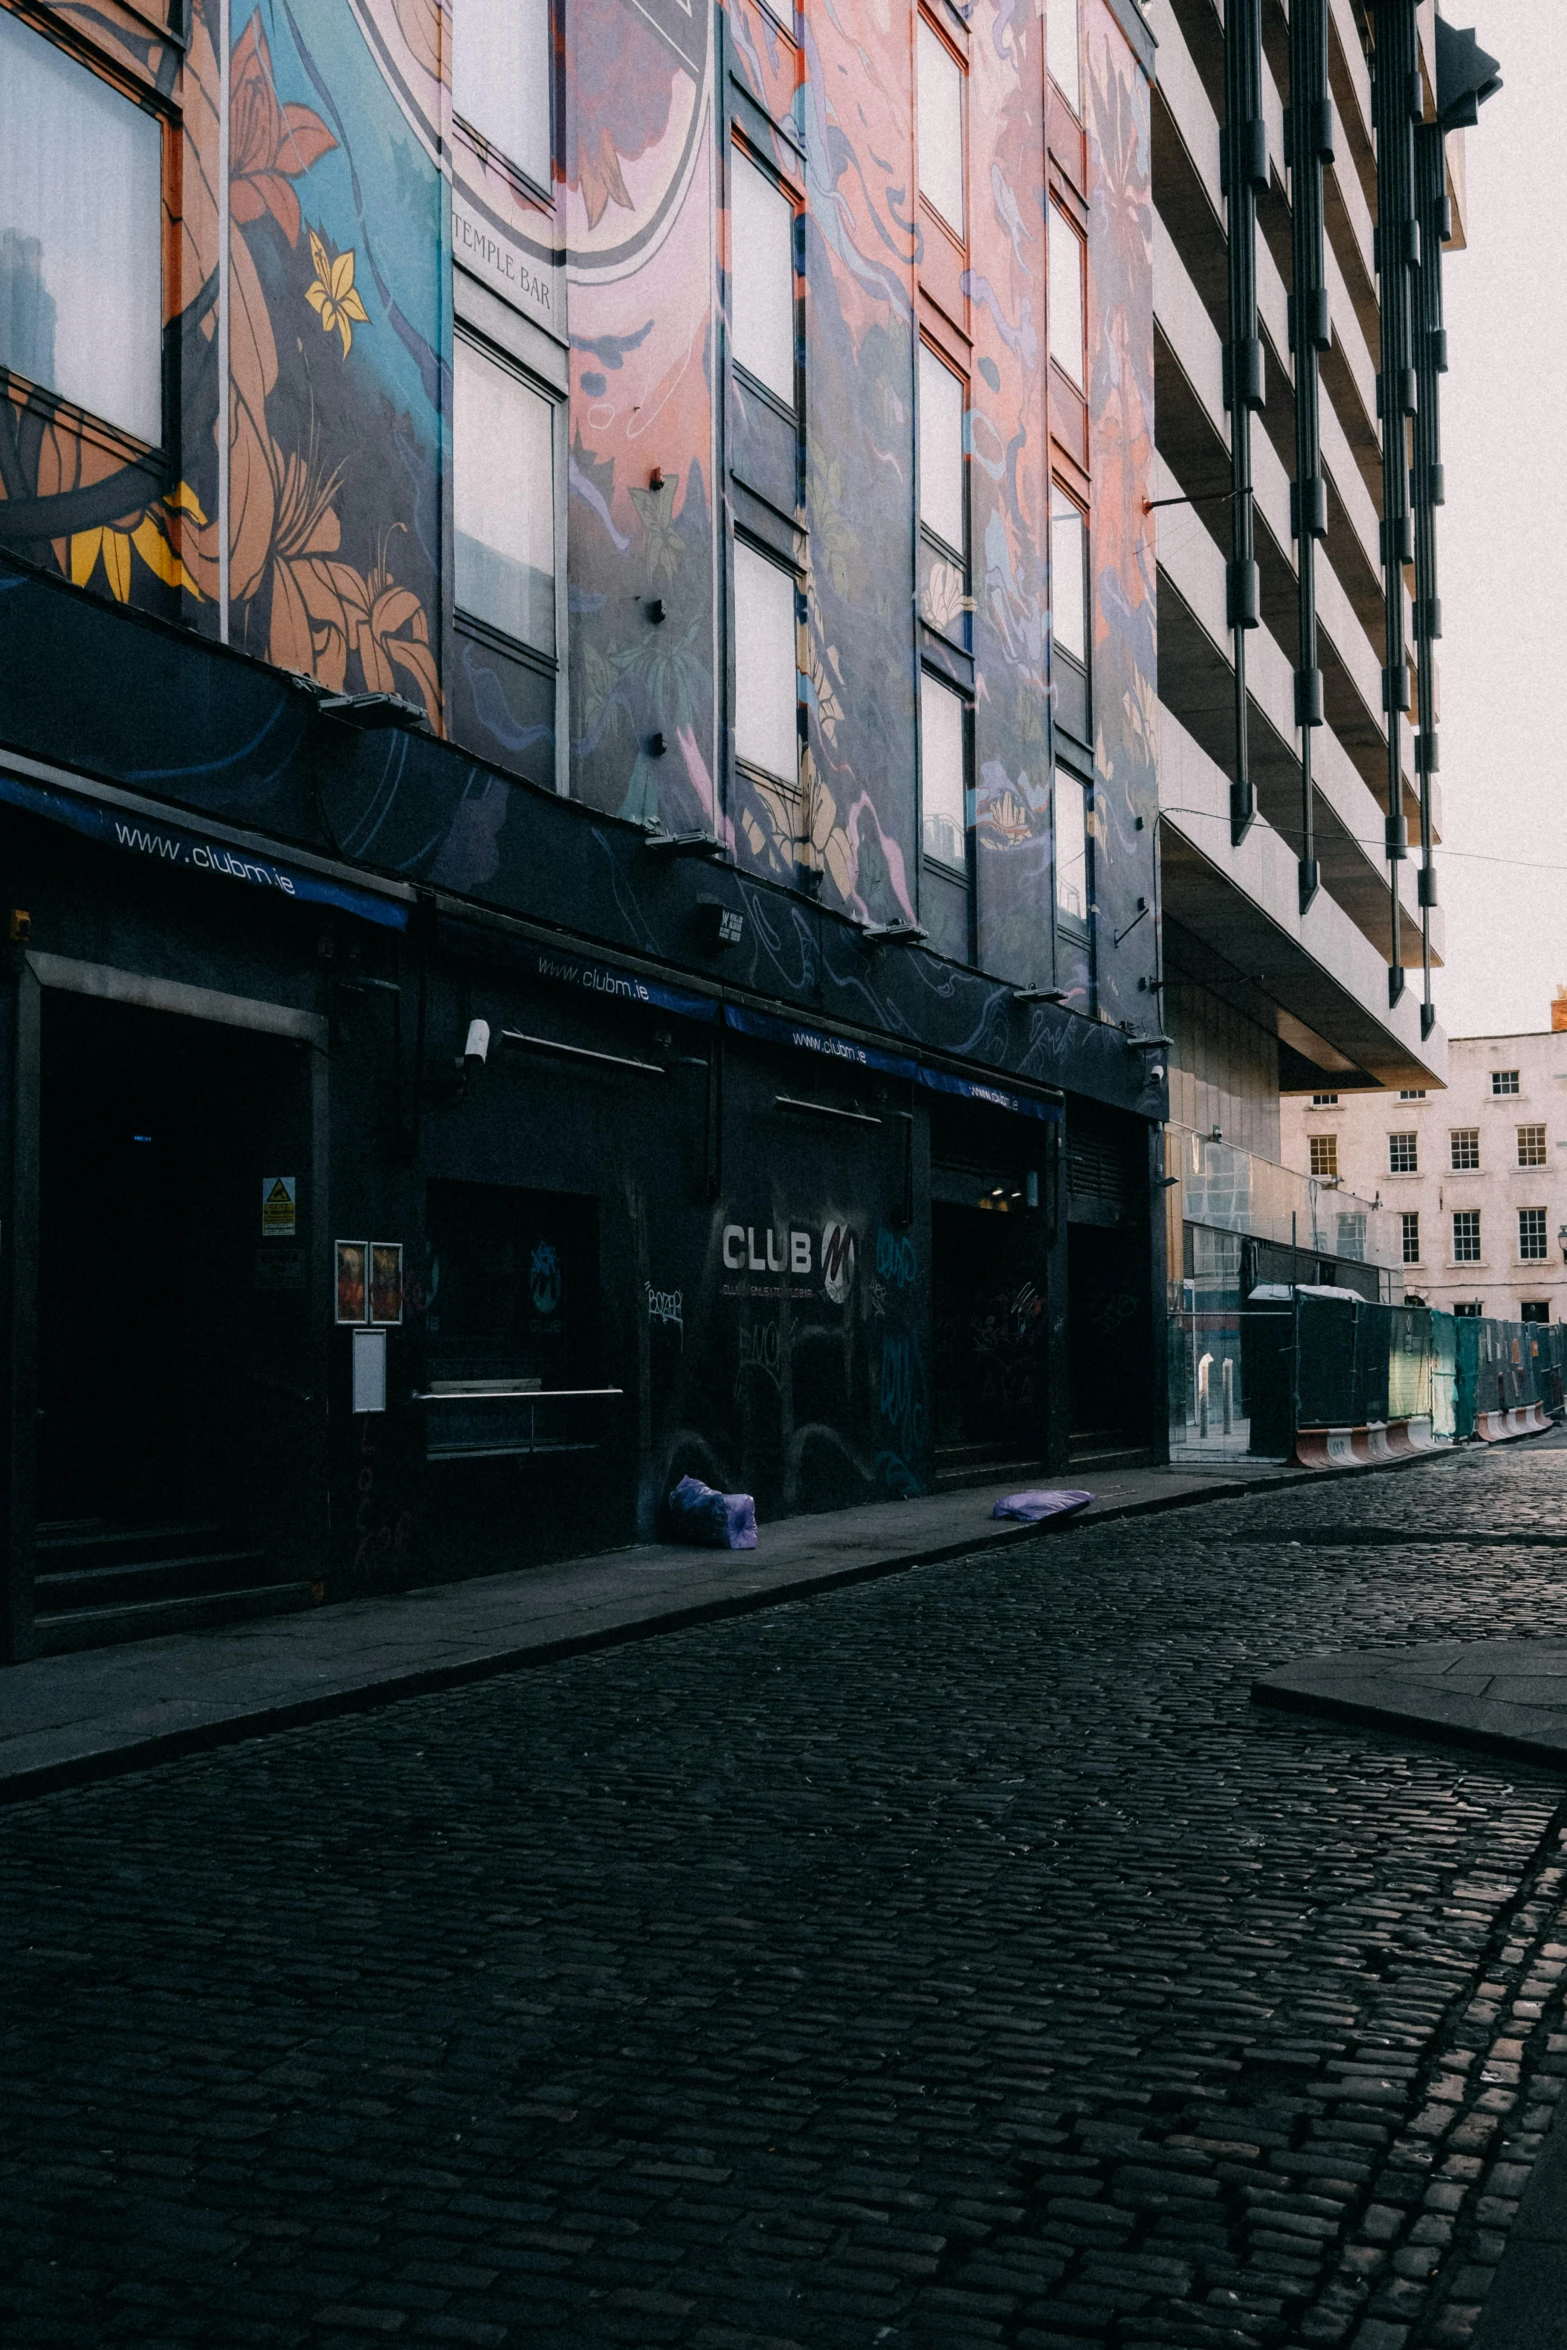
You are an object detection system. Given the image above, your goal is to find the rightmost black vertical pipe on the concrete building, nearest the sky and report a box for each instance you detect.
[1410,122,1452,1036]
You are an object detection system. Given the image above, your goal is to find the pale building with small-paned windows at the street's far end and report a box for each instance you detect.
[1283,1006,1567,1321]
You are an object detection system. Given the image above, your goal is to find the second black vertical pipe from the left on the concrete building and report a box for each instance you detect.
[1285,0,1332,914]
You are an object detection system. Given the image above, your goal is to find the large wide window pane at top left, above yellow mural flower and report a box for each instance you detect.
[0,12,162,444]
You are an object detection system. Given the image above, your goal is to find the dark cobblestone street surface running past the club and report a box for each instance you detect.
[0,1448,1567,2350]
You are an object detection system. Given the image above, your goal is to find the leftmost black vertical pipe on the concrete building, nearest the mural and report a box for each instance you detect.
[1219,0,1269,846]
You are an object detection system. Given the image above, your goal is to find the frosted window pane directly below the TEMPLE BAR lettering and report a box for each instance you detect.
[451,341,554,653]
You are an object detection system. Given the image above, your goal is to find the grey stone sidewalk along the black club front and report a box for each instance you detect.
[0,1428,1419,1802]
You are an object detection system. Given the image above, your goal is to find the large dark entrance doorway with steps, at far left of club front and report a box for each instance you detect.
[38,989,315,1638]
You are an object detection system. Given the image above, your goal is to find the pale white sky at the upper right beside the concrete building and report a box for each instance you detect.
[1431,0,1567,1036]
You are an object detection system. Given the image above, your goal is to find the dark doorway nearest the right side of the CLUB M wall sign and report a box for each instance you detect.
[930,1201,1045,1483]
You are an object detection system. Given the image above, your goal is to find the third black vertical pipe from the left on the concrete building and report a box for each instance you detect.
[1372,0,1424,1003]
